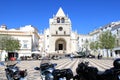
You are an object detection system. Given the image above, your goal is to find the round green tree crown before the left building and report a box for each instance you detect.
[0,35,20,52]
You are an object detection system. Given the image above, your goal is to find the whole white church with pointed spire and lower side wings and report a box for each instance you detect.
[43,7,78,55]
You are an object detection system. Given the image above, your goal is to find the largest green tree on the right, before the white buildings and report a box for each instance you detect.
[99,31,116,57]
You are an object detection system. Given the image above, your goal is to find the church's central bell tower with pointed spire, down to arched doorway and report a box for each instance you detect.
[49,7,71,54]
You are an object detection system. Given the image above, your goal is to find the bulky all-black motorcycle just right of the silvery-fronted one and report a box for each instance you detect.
[73,62,98,80]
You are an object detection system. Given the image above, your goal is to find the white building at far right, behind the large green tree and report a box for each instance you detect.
[89,21,120,57]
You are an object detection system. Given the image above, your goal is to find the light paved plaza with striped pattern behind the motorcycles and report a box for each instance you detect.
[0,58,113,80]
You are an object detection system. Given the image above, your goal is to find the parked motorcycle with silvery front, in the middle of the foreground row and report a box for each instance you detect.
[34,63,73,80]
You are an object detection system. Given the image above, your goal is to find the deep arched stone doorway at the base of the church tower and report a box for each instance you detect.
[55,38,66,51]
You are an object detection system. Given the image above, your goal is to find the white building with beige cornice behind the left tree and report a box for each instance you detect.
[0,25,40,59]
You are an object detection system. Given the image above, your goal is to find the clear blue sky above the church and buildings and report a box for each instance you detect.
[0,0,120,34]
